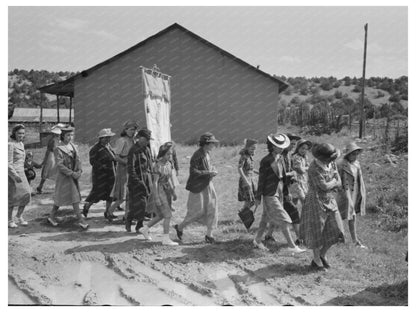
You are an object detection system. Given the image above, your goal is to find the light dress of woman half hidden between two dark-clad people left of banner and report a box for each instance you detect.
[111,136,134,200]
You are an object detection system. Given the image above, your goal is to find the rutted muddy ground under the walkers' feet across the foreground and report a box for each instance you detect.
[9,185,407,306]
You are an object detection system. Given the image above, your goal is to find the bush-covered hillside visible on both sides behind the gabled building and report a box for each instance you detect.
[8,69,408,121]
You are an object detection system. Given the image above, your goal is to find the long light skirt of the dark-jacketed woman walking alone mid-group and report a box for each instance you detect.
[182,182,218,229]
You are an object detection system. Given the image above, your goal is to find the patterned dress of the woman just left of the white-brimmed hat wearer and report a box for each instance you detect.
[238,150,256,207]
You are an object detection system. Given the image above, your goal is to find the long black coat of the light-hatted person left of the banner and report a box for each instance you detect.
[85,142,115,203]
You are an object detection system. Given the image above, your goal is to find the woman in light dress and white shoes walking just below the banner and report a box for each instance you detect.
[141,142,178,246]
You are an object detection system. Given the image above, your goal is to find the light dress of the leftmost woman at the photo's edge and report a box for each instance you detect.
[8,141,31,207]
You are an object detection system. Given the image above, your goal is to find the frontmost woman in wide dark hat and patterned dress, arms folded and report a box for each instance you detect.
[300,143,345,271]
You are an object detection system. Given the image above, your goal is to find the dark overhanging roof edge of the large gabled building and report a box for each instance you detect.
[39,23,289,97]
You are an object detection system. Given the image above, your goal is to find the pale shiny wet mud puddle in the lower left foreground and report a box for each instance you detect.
[9,261,216,306]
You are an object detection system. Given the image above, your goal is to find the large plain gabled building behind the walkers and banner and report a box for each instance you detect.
[40,23,287,143]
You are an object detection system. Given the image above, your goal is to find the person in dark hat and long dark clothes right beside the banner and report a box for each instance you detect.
[126,128,153,235]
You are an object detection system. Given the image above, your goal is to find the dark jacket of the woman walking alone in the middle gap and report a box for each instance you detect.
[186,147,212,193]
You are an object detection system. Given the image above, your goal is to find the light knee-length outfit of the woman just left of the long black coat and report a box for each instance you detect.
[54,143,81,206]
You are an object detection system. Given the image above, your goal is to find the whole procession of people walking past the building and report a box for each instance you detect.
[8,121,366,271]
